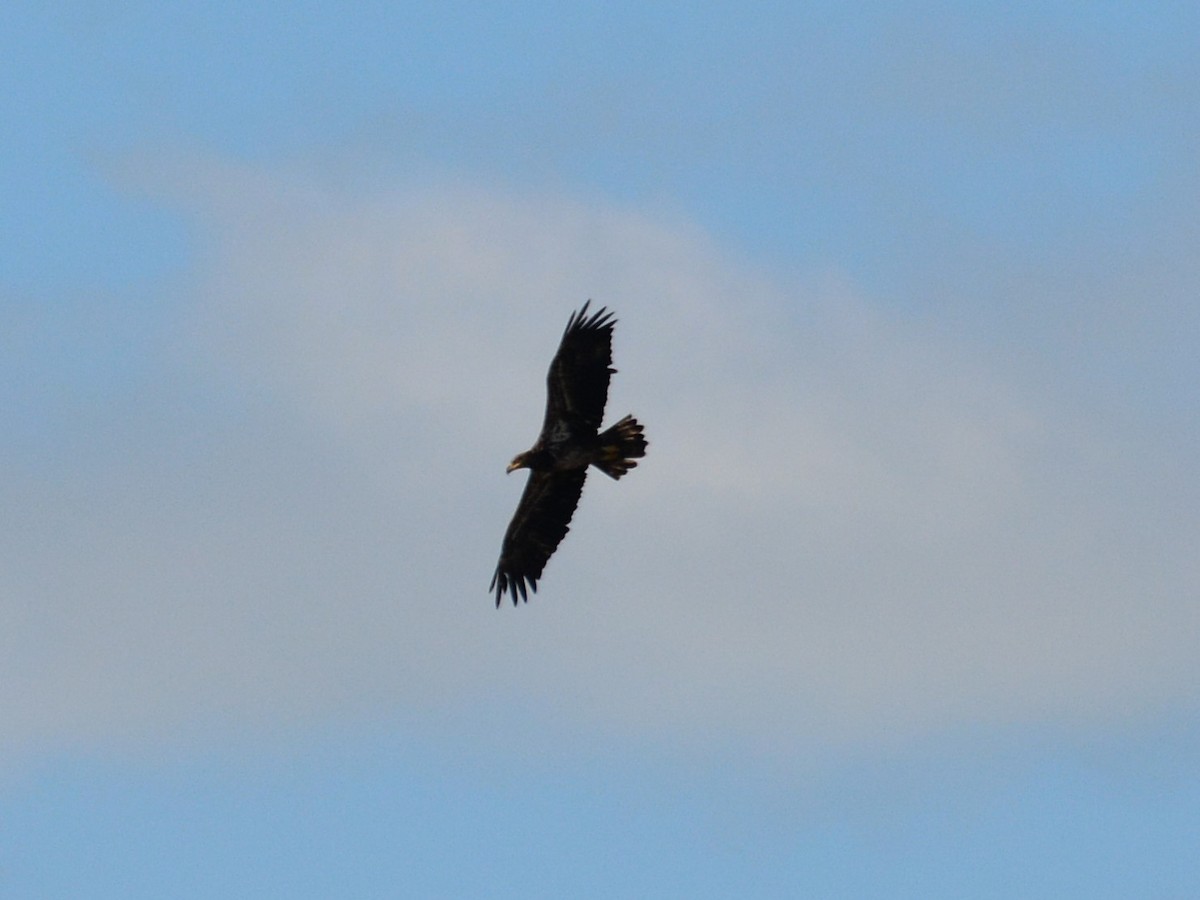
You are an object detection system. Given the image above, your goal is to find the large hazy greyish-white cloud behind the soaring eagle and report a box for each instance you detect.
[0,157,1200,768]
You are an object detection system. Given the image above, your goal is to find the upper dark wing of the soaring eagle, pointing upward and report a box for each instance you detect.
[542,300,617,433]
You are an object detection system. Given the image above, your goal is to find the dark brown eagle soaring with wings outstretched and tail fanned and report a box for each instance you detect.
[488,300,646,608]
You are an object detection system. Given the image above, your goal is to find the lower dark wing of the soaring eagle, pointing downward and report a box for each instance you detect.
[488,468,587,606]
